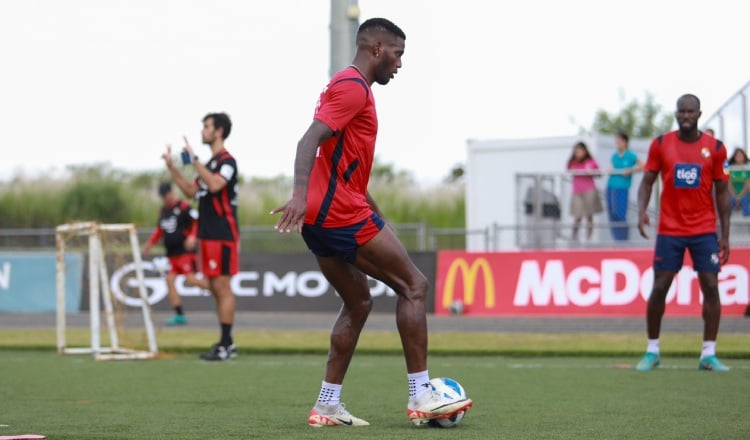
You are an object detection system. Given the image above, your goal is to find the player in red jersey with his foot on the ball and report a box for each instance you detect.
[271,18,472,427]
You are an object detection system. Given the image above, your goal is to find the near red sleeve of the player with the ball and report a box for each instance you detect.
[315,78,368,133]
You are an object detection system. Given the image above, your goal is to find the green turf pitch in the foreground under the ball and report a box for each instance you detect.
[0,349,750,440]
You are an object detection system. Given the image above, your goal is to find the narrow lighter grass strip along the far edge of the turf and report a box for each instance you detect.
[0,328,750,359]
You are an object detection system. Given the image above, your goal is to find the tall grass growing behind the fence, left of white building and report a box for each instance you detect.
[0,164,465,228]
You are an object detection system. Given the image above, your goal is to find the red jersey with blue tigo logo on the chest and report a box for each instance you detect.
[643,131,729,236]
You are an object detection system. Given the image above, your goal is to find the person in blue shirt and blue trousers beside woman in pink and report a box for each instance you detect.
[606,132,643,240]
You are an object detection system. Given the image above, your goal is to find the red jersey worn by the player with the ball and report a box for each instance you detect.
[305,67,378,228]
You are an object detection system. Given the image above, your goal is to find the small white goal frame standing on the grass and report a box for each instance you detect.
[55,222,159,360]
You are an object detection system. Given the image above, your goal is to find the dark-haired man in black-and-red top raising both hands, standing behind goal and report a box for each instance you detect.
[162,113,240,361]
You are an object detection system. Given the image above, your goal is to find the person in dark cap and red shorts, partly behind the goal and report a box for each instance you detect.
[143,182,208,325]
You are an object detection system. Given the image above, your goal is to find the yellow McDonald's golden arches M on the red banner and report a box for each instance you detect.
[443,258,495,309]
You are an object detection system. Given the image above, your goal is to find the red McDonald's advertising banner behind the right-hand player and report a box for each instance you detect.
[435,248,750,316]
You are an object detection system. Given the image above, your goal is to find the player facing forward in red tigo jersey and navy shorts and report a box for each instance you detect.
[636,94,731,371]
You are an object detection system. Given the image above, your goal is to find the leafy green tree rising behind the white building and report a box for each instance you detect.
[581,93,674,139]
